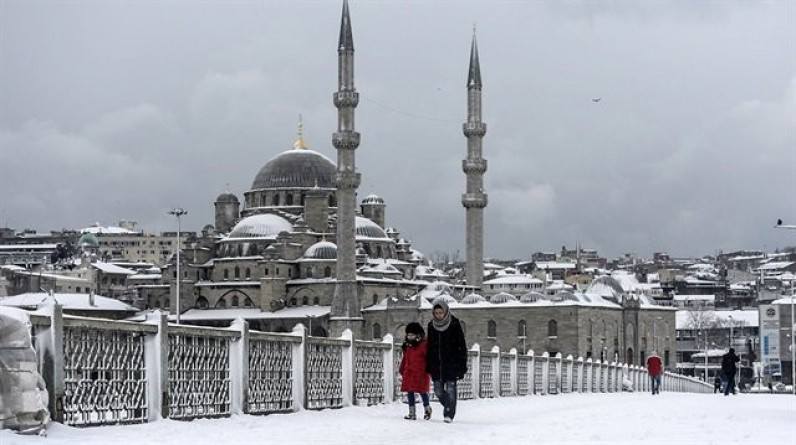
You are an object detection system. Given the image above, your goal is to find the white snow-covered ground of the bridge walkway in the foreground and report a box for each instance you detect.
[0,393,796,445]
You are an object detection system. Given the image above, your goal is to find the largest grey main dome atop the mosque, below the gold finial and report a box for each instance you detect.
[252,148,337,190]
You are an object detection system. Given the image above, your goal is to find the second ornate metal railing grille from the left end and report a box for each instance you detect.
[168,334,230,420]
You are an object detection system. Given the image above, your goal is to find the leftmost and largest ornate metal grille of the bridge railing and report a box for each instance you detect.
[63,327,149,426]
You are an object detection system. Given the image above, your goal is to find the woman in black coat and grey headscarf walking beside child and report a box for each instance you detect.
[426,298,467,423]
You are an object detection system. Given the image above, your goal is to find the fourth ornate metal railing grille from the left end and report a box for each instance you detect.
[306,339,343,409]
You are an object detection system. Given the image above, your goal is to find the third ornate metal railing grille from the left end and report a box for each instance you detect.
[247,339,293,414]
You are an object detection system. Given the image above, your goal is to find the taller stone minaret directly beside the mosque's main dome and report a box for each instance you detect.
[330,0,363,338]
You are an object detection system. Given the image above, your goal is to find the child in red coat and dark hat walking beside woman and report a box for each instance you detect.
[398,322,431,420]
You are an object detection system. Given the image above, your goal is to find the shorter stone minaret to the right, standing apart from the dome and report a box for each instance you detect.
[462,29,487,288]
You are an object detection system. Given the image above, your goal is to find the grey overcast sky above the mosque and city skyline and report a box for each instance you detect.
[0,0,796,258]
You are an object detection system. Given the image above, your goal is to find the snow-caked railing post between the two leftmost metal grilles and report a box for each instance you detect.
[144,310,169,422]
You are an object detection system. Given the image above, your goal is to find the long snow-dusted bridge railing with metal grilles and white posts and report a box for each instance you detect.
[31,306,712,427]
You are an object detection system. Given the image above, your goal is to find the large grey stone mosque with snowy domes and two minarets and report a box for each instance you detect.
[139,0,676,369]
